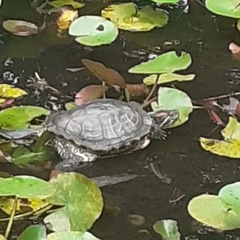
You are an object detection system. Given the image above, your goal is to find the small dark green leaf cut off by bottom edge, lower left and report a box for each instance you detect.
[18,225,47,240]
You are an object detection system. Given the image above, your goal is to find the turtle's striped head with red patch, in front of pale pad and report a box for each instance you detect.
[150,109,179,129]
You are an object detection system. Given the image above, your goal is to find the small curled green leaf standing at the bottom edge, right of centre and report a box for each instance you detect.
[153,219,181,240]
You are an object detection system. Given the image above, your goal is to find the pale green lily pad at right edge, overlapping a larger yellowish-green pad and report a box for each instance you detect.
[218,182,240,218]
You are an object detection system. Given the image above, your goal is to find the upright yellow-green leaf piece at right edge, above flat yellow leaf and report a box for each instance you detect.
[221,117,240,141]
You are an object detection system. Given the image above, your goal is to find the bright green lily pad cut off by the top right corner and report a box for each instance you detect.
[205,0,240,18]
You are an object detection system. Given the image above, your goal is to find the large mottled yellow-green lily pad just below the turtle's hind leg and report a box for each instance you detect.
[49,173,103,231]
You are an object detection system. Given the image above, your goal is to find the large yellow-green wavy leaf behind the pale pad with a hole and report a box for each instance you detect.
[101,3,169,31]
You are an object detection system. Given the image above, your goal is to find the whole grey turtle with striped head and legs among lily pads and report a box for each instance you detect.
[1,98,179,171]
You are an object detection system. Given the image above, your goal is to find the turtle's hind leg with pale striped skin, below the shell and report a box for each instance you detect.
[52,138,98,172]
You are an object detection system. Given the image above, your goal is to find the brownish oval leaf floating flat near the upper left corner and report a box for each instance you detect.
[3,20,39,37]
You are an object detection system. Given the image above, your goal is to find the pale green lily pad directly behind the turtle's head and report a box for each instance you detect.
[151,87,193,127]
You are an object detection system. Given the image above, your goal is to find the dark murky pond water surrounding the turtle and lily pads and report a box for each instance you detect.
[0,0,240,240]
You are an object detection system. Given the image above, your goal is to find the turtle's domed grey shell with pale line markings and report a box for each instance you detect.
[45,99,152,151]
